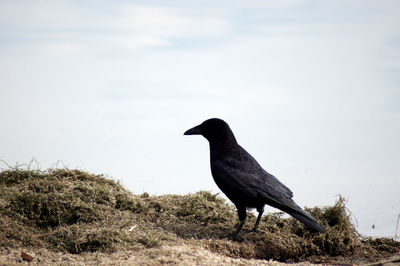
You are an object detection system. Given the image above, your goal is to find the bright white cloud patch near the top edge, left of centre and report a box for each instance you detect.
[95,5,229,46]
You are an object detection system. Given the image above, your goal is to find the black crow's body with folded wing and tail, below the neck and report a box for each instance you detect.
[211,145,324,232]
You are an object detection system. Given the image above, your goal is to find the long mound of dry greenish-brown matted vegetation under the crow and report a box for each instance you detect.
[0,169,400,262]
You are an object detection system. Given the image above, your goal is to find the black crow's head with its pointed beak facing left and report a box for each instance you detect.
[184,118,236,143]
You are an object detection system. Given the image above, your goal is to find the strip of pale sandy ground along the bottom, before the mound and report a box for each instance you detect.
[0,244,311,265]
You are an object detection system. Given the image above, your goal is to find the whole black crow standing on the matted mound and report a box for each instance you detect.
[184,118,324,238]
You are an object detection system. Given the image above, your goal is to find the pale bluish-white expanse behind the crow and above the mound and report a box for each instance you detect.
[0,0,400,236]
